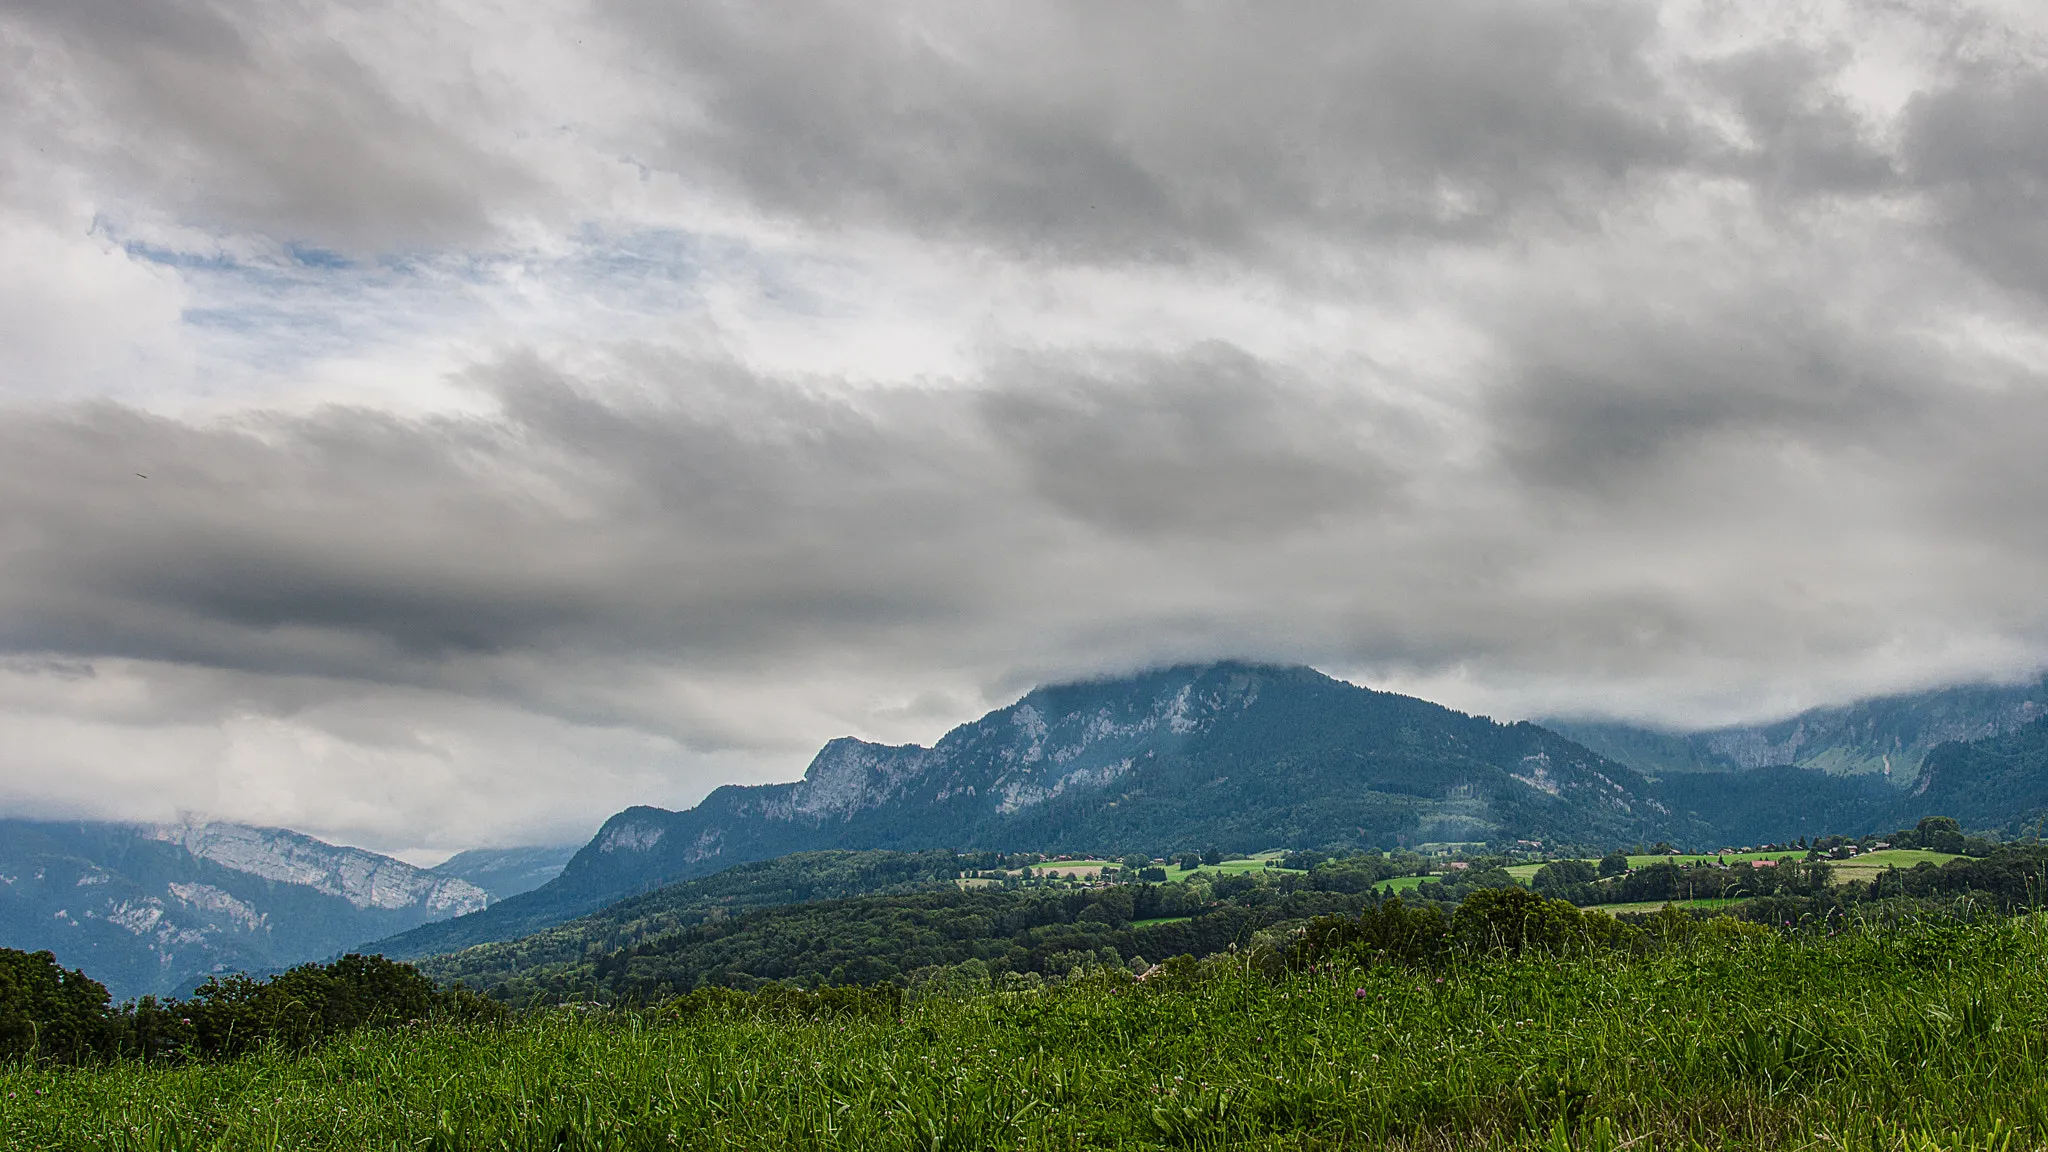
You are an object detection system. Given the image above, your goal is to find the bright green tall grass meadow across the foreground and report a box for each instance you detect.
[0,916,2048,1152]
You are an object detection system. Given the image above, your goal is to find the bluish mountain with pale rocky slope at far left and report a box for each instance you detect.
[0,820,489,998]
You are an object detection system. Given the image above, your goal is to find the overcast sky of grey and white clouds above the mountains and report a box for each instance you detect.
[0,0,2048,857]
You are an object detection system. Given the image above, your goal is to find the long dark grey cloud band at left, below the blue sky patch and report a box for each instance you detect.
[0,361,1015,701]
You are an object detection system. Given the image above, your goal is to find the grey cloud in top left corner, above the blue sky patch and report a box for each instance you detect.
[0,0,530,252]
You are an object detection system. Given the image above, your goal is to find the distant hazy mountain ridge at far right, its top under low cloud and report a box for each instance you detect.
[1542,676,2048,787]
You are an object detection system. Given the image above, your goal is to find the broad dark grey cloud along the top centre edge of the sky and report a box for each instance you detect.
[606,0,1702,260]
